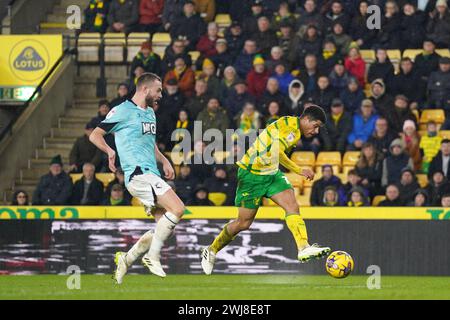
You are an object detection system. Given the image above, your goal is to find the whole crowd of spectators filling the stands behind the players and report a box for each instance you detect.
[9,0,450,207]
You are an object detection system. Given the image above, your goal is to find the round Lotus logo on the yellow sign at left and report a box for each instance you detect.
[9,40,50,82]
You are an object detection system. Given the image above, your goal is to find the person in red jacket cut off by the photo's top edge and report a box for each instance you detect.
[139,0,164,34]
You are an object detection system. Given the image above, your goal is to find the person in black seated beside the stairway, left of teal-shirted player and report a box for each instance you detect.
[69,122,102,173]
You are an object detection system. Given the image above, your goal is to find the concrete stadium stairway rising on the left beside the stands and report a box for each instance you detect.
[3,65,127,203]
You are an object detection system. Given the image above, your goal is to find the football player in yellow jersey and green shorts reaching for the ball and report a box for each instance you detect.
[201,105,331,275]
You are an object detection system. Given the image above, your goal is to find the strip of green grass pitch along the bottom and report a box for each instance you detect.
[0,275,450,300]
